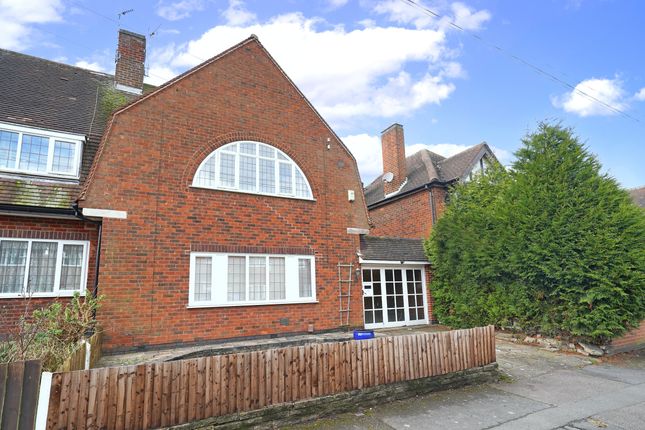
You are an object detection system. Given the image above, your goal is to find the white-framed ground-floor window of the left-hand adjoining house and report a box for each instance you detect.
[0,238,89,298]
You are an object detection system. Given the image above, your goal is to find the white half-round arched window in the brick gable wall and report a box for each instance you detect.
[193,141,313,200]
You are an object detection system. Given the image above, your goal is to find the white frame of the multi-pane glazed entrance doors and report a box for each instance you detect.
[361,263,430,329]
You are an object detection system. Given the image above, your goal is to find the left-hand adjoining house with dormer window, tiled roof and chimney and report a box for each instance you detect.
[0,31,145,338]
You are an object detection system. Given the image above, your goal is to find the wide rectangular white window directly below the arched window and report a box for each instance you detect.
[188,252,316,307]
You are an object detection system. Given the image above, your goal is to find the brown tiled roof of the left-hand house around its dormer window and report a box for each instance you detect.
[0,49,138,209]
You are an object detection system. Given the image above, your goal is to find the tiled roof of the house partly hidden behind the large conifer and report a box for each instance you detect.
[365,143,495,206]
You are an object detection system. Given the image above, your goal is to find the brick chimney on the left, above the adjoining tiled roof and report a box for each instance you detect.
[114,30,146,94]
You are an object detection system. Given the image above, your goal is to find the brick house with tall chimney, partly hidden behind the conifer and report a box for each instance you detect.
[365,124,498,239]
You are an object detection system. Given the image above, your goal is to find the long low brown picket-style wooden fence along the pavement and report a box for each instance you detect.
[47,326,495,429]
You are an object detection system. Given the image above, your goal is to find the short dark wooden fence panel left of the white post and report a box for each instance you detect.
[0,360,42,430]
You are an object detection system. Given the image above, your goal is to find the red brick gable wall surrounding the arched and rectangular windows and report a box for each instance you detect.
[82,40,368,350]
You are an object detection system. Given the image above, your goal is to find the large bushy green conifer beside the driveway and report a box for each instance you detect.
[426,123,645,341]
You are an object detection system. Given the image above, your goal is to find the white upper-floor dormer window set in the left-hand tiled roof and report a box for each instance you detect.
[0,123,85,179]
